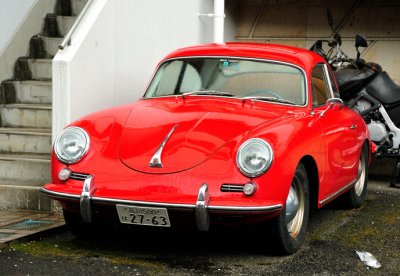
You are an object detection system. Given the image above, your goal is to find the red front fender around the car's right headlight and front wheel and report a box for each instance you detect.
[247,112,325,205]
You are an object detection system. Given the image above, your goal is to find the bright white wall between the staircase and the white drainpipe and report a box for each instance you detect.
[53,0,235,137]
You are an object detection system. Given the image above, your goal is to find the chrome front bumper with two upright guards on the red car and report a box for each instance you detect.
[41,176,283,231]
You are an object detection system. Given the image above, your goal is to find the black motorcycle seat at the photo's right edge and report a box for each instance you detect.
[366,72,400,104]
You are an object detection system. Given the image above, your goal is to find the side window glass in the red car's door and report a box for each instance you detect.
[311,64,331,106]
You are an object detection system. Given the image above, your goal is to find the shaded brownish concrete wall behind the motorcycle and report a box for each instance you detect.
[236,0,400,84]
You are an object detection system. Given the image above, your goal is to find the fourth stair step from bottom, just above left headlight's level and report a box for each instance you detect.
[0,104,51,128]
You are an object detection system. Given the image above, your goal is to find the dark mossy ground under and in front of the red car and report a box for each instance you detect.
[0,181,400,275]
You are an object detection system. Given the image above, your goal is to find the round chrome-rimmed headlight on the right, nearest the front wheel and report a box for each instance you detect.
[236,138,273,177]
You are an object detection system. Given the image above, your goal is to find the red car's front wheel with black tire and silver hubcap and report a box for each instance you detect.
[271,163,310,254]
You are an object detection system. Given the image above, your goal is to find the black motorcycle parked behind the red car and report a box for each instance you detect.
[310,9,400,188]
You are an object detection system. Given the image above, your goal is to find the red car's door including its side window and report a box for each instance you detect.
[311,64,360,199]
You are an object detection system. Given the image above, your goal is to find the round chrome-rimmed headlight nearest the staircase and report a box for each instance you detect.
[54,127,90,164]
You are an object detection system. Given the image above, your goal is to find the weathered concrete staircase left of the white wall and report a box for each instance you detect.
[0,0,87,211]
